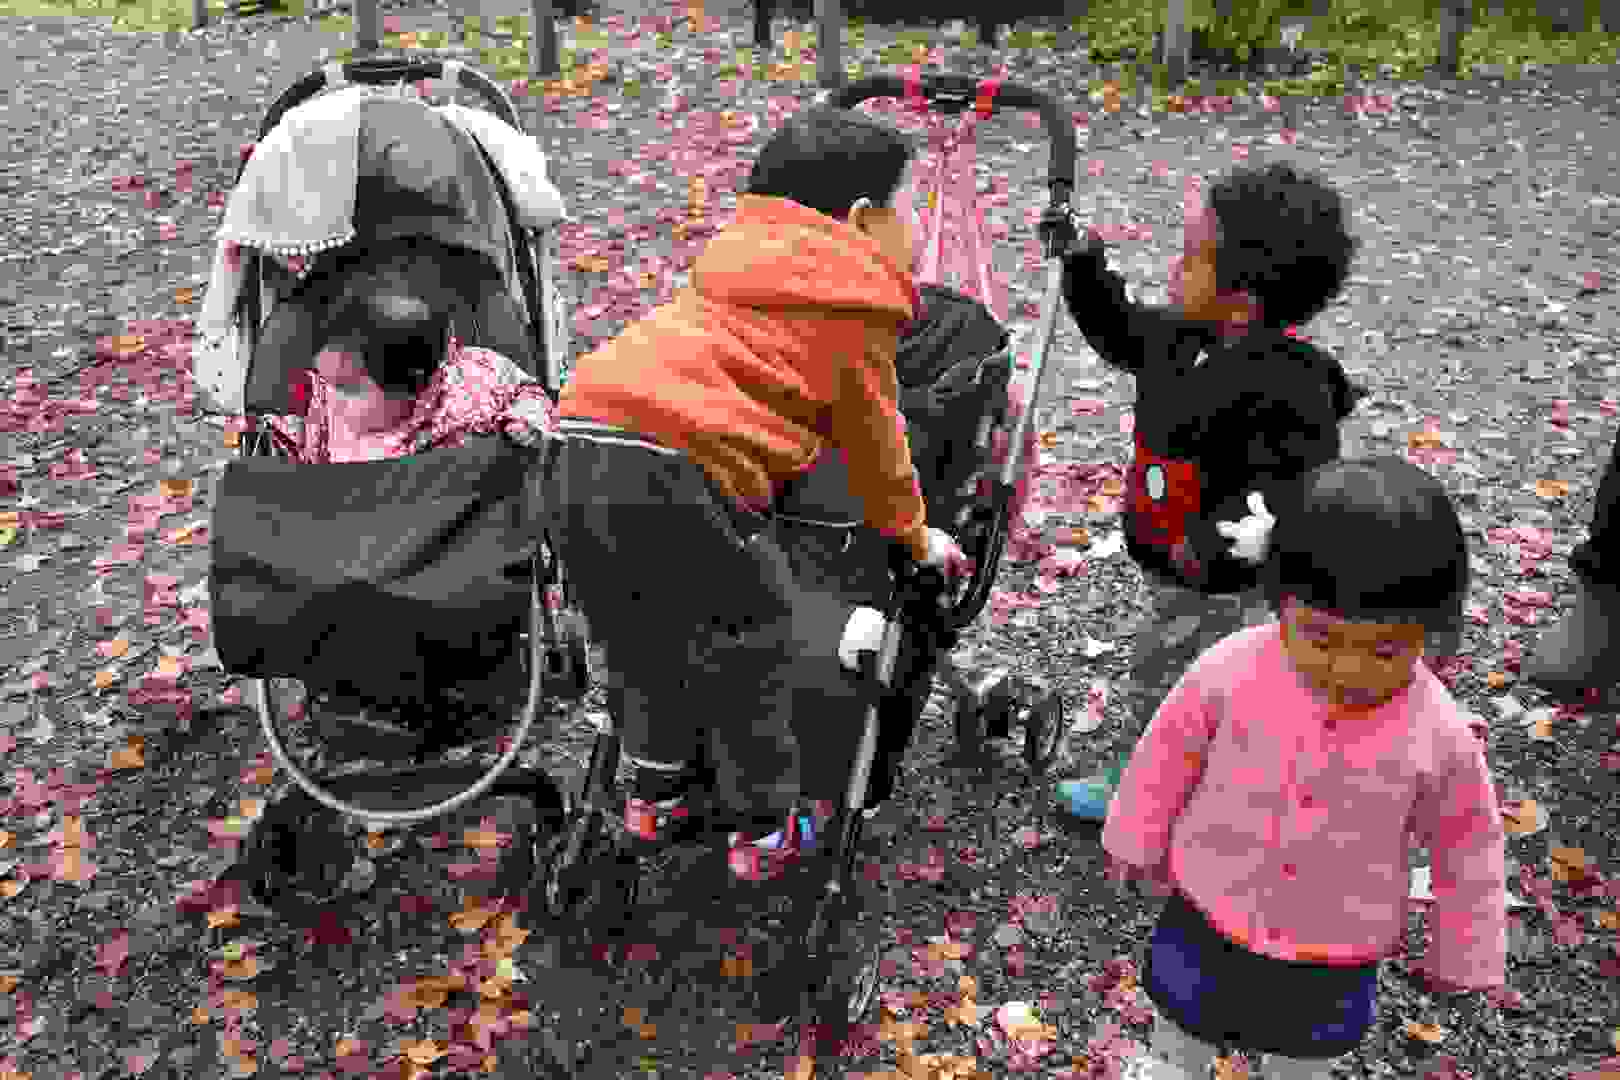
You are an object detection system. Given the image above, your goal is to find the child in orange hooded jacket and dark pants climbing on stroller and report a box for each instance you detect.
[552,108,962,839]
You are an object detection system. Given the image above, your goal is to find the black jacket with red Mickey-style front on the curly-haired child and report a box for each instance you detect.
[1063,246,1366,594]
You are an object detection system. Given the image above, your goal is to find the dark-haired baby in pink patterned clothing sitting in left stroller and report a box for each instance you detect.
[269,238,557,463]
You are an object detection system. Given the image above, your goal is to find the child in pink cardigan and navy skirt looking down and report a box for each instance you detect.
[1102,458,1507,1080]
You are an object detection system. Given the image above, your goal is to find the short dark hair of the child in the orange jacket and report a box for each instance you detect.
[747,105,915,220]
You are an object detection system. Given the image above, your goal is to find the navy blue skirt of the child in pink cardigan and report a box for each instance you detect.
[1145,891,1379,1059]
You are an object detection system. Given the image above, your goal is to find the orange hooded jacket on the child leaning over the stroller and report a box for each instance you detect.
[559,194,928,560]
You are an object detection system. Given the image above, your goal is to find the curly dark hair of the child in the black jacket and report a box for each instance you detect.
[1209,162,1361,327]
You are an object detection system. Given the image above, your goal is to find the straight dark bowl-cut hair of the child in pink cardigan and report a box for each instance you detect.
[1262,457,1468,635]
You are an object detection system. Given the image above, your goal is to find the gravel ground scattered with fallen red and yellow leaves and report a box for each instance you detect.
[0,5,1620,1080]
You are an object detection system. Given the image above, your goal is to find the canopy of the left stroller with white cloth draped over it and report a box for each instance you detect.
[203,87,535,413]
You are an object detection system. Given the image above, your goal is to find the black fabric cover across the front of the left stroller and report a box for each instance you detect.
[209,437,539,706]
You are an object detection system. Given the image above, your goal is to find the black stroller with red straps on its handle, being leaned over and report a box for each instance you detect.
[778,74,1074,803]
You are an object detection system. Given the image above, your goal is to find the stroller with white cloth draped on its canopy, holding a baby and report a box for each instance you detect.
[198,58,586,907]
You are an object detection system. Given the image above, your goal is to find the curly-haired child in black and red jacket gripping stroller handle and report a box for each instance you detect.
[1043,165,1393,821]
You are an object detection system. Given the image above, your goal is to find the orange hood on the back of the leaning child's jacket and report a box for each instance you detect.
[692,194,915,322]
